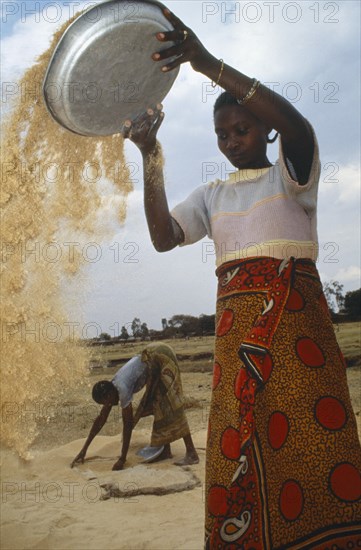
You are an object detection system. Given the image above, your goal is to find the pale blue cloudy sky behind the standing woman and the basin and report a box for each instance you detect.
[1,0,361,336]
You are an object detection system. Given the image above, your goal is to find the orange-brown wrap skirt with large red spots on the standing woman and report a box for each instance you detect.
[206,258,361,550]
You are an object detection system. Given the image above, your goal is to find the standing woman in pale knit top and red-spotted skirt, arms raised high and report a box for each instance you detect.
[123,6,361,550]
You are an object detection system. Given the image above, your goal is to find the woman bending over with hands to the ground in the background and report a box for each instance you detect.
[71,343,199,470]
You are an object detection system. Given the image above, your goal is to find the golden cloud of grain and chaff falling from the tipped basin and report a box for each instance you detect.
[0,16,132,458]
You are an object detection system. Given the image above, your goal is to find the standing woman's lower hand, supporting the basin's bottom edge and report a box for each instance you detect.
[122,104,164,154]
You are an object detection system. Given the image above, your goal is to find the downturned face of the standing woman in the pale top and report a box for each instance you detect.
[214,105,271,169]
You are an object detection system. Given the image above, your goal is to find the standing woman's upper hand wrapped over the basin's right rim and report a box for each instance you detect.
[152,9,213,72]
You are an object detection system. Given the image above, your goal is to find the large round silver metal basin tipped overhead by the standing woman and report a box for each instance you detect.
[43,0,179,136]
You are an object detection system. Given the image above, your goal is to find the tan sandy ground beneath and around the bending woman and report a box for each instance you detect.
[1,367,361,550]
